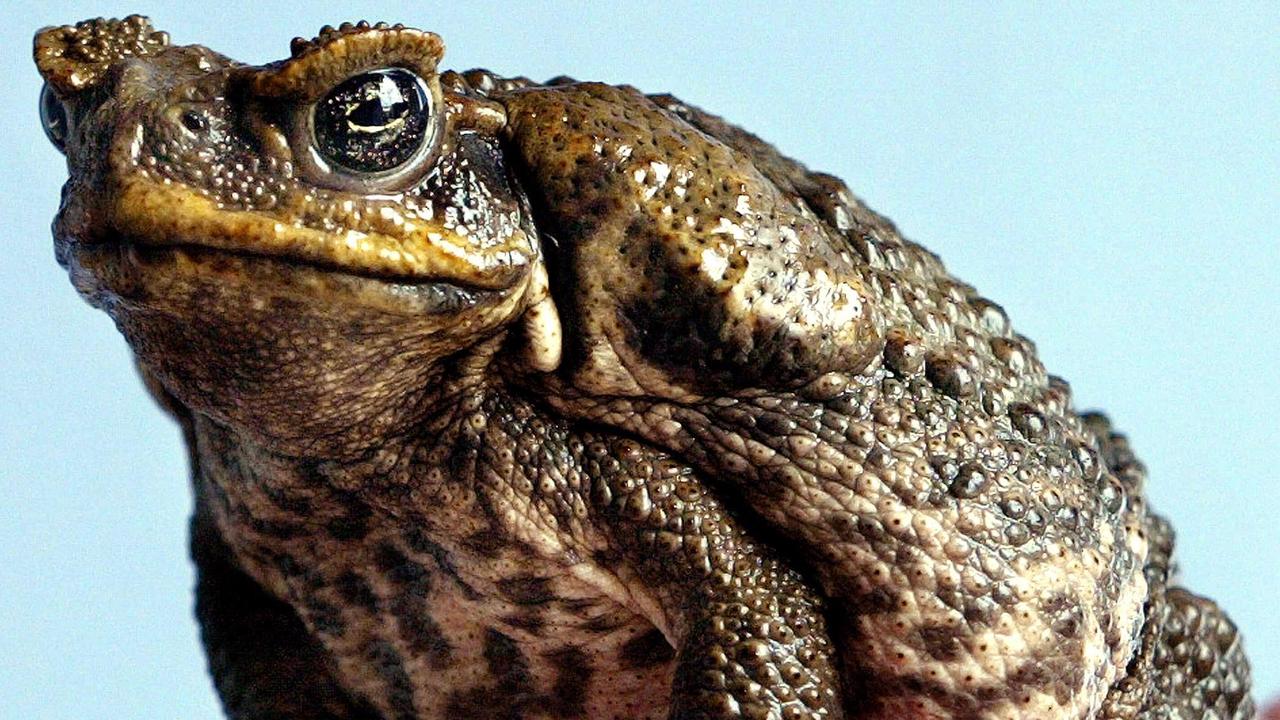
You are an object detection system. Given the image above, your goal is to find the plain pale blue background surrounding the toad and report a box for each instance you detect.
[0,0,1280,719]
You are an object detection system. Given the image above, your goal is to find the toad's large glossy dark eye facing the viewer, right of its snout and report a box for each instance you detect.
[312,68,430,173]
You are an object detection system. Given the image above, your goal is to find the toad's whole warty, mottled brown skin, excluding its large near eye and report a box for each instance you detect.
[36,17,1253,720]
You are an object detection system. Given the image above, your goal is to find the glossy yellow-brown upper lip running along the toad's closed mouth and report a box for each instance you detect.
[93,172,531,291]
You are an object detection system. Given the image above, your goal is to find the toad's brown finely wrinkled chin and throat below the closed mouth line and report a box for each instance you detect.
[60,235,521,452]
